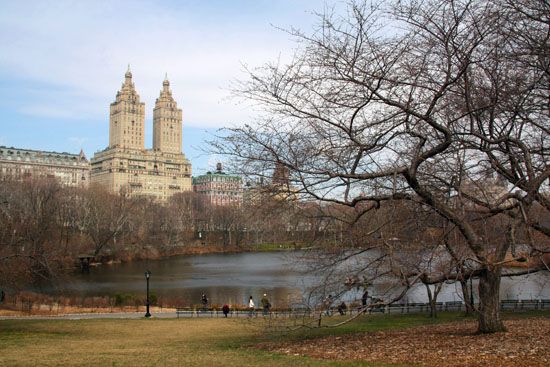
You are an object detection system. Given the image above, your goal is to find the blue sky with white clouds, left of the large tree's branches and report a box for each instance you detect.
[0,0,339,175]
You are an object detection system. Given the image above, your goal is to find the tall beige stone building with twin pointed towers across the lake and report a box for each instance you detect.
[91,68,192,201]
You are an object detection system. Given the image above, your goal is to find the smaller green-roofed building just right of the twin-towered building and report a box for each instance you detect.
[193,163,243,206]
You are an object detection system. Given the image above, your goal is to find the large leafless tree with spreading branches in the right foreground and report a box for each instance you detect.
[214,0,550,333]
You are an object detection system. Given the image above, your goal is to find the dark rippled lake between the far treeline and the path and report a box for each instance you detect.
[42,252,550,306]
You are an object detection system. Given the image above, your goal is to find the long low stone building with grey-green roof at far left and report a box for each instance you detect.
[0,146,90,187]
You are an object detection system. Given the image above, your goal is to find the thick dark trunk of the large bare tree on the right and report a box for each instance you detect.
[477,266,506,334]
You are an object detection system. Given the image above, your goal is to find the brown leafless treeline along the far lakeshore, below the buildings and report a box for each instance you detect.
[0,178,336,287]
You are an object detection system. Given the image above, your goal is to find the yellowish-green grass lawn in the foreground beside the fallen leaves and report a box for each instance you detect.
[0,313,548,367]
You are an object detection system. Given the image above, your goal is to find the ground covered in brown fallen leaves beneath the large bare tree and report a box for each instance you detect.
[264,317,550,367]
